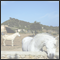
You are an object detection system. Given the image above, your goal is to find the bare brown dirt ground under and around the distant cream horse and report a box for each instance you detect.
[1,33,32,51]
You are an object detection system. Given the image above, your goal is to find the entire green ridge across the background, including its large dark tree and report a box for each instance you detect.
[2,17,59,33]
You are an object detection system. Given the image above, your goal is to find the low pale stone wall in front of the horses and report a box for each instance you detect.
[1,51,59,59]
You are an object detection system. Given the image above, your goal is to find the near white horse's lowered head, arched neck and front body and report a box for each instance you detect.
[22,33,57,58]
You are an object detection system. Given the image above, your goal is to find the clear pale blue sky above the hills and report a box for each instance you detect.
[1,1,59,26]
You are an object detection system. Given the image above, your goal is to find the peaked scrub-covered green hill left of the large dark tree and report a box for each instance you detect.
[2,17,30,28]
